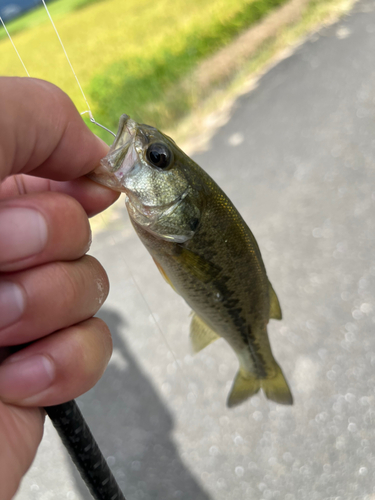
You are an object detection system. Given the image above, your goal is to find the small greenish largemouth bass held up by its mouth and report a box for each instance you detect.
[91,115,293,407]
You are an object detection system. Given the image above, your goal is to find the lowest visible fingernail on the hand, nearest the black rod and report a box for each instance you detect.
[0,354,55,401]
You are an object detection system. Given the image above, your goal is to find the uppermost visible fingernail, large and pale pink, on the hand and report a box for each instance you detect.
[0,207,48,264]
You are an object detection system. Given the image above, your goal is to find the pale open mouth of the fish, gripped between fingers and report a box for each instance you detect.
[88,114,138,192]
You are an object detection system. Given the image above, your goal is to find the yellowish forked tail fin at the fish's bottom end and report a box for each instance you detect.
[227,363,293,408]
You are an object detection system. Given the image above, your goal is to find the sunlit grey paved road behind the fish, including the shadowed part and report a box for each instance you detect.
[16,0,375,500]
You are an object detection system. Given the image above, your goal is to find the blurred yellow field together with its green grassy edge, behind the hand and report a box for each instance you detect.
[0,0,286,140]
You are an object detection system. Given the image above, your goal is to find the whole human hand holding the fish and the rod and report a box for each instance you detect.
[0,78,118,500]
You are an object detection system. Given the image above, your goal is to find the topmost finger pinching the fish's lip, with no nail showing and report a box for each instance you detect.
[0,77,108,181]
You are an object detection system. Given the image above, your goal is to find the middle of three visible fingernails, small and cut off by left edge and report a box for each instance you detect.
[0,281,25,329]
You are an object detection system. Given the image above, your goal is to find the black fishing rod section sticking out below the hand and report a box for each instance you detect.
[44,400,126,500]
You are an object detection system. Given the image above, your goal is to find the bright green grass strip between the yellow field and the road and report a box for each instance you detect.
[89,0,285,137]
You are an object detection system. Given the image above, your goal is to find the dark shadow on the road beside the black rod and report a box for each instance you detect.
[65,308,210,500]
